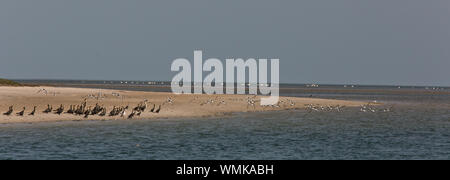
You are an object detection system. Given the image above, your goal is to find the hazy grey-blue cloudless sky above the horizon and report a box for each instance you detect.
[0,0,450,86]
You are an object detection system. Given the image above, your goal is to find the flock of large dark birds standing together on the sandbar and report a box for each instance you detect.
[3,99,161,119]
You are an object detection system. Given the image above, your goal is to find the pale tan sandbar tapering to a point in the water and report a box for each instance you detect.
[0,87,366,123]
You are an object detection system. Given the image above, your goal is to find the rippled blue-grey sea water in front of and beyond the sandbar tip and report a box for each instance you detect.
[0,80,450,160]
